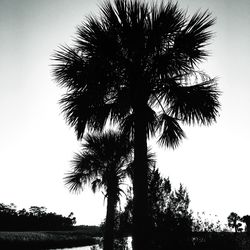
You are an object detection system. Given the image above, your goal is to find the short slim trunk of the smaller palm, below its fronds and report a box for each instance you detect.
[103,190,116,250]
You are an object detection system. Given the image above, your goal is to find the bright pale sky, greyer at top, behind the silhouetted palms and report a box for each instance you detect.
[0,0,250,224]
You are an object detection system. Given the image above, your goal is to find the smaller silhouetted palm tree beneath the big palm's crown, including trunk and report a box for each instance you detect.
[65,131,132,250]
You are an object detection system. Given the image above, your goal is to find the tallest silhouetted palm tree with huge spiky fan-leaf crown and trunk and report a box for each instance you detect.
[53,0,220,250]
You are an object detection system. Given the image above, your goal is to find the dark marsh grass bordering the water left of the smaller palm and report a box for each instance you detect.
[0,231,98,250]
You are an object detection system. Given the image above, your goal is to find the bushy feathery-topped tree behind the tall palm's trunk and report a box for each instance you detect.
[117,167,192,250]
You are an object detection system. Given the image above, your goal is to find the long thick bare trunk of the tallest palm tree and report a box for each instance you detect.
[133,106,150,250]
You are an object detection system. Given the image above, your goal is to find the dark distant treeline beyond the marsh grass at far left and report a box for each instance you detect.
[0,203,76,231]
